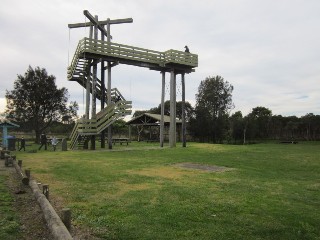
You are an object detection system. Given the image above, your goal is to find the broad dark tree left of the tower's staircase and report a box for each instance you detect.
[6,66,78,142]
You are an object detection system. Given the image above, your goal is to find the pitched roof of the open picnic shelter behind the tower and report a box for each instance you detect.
[127,113,182,126]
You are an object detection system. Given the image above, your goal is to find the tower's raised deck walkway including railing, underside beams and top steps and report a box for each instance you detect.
[68,38,198,80]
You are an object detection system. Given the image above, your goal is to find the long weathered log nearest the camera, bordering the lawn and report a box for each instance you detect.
[29,180,73,240]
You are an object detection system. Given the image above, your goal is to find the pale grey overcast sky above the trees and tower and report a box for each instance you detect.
[0,0,320,116]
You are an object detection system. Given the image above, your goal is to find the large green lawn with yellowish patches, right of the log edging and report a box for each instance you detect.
[13,143,320,240]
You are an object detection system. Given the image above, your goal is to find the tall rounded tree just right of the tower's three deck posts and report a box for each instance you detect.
[195,76,234,142]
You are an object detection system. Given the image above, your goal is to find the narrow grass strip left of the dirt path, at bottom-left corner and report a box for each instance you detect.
[0,174,21,240]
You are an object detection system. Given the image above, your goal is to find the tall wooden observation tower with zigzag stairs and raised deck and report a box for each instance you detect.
[68,10,198,149]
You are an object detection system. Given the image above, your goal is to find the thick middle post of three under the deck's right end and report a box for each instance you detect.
[169,69,176,148]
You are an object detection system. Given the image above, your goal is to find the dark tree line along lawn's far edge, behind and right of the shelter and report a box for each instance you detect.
[138,76,320,144]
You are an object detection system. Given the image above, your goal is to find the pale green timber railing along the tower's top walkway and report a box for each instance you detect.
[68,38,198,80]
